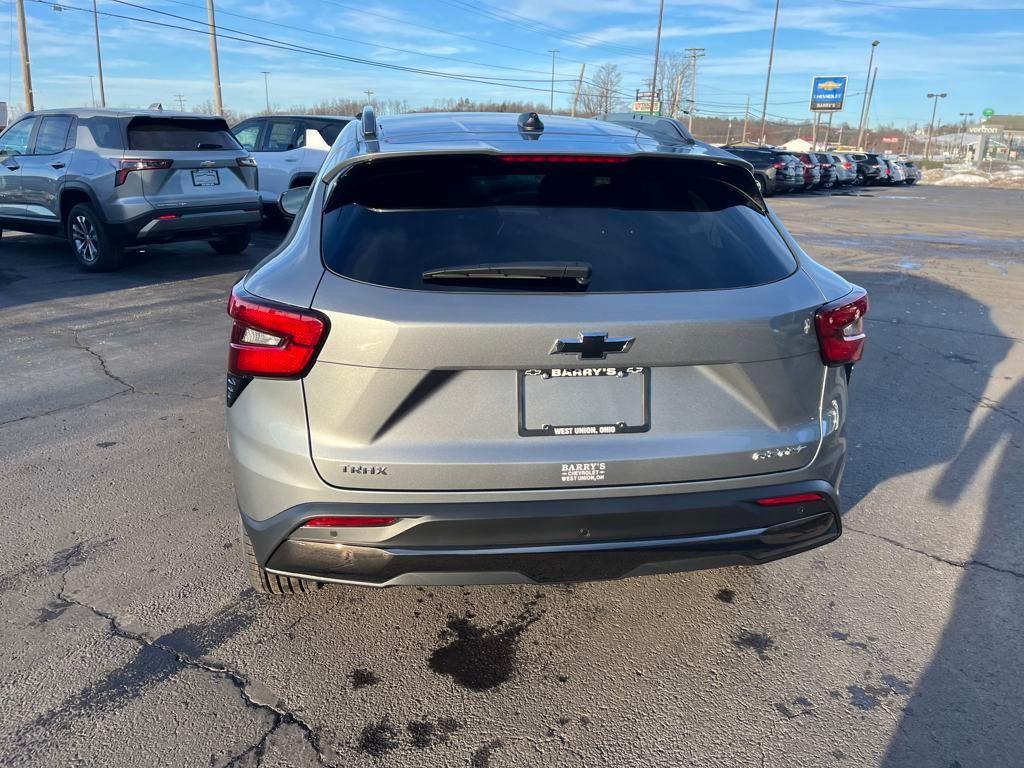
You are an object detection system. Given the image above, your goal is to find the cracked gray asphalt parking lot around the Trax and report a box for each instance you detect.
[0,186,1024,768]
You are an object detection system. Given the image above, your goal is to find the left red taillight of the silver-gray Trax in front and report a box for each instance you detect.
[227,286,330,379]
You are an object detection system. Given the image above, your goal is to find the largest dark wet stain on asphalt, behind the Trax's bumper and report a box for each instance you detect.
[428,599,543,691]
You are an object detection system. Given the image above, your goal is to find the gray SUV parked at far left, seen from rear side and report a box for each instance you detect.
[0,110,260,271]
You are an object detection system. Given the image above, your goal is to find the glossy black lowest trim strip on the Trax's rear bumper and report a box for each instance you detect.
[266,510,842,587]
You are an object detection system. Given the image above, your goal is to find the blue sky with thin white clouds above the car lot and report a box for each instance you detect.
[0,0,1024,127]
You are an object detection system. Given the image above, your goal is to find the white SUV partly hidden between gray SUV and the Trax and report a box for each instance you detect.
[231,115,351,213]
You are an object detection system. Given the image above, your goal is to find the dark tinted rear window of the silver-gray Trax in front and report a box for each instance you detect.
[323,156,797,293]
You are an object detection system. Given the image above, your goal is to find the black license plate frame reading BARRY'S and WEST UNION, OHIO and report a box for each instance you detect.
[516,366,651,437]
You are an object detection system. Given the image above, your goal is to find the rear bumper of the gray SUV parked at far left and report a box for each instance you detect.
[113,204,262,243]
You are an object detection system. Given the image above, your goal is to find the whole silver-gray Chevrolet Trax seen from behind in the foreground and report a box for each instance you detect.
[226,110,867,594]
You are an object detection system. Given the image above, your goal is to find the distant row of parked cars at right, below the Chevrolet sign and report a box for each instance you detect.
[723,145,921,195]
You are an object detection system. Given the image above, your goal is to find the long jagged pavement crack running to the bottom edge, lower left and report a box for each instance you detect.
[56,561,337,768]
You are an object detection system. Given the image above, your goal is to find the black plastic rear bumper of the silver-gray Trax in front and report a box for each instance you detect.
[243,480,842,587]
